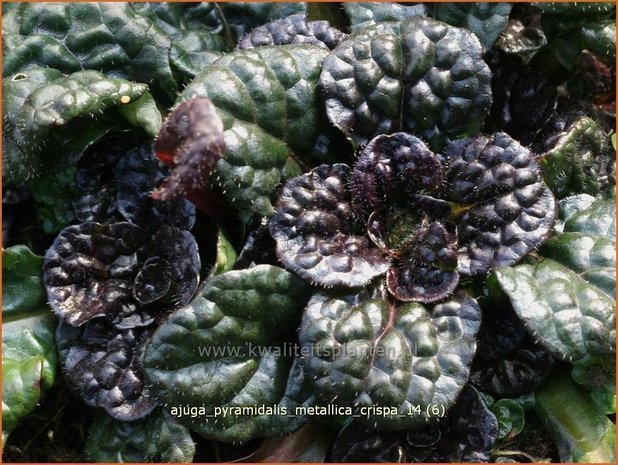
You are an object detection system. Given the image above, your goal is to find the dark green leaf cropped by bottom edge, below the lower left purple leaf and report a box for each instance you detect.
[86,410,195,463]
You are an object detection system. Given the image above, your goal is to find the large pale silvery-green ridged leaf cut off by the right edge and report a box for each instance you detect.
[496,194,616,361]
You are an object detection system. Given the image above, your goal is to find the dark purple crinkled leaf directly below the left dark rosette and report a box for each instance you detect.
[56,319,157,421]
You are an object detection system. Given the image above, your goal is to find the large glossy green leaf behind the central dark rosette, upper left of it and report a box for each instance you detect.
[181,45,345,215]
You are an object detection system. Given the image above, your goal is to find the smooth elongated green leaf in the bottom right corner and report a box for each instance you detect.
[535,371,616,463]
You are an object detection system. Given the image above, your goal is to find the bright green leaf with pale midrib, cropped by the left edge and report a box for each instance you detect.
[2,246,57,446]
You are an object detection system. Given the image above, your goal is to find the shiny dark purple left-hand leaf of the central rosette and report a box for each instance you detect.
[269,164,389,287]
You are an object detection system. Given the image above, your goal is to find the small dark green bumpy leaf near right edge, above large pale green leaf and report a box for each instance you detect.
[541,117,615,198]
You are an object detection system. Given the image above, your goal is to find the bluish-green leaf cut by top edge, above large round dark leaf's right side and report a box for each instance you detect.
[434,2,512,51]
